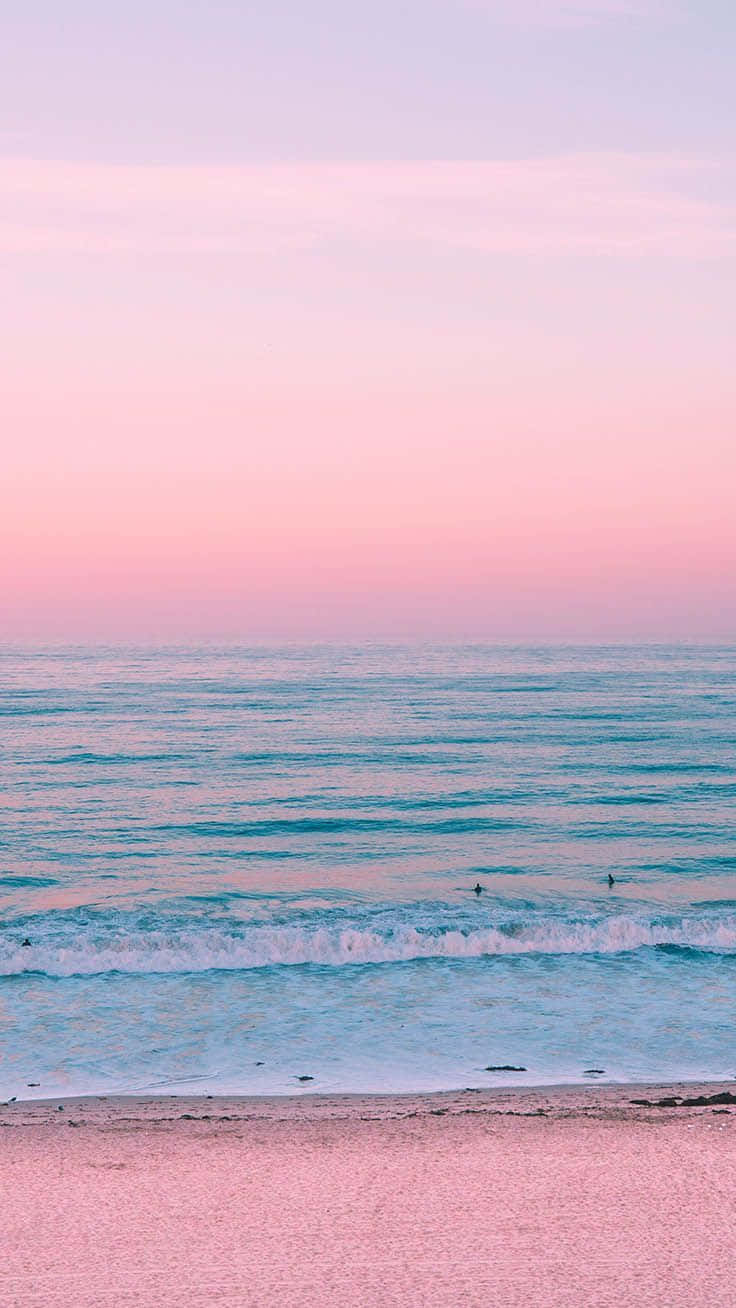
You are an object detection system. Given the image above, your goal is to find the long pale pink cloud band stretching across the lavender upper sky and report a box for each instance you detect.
[0,154,736,258]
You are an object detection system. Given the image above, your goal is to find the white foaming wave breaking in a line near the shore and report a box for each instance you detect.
[0,916,736,977]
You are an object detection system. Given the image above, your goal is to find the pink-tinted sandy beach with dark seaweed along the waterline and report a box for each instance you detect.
[0,1084,736,1308]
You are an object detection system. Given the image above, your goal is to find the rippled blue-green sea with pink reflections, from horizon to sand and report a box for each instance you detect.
[0,645,736,1099]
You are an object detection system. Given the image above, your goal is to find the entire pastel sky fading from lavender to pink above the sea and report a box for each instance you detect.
[0,0,736,642]
